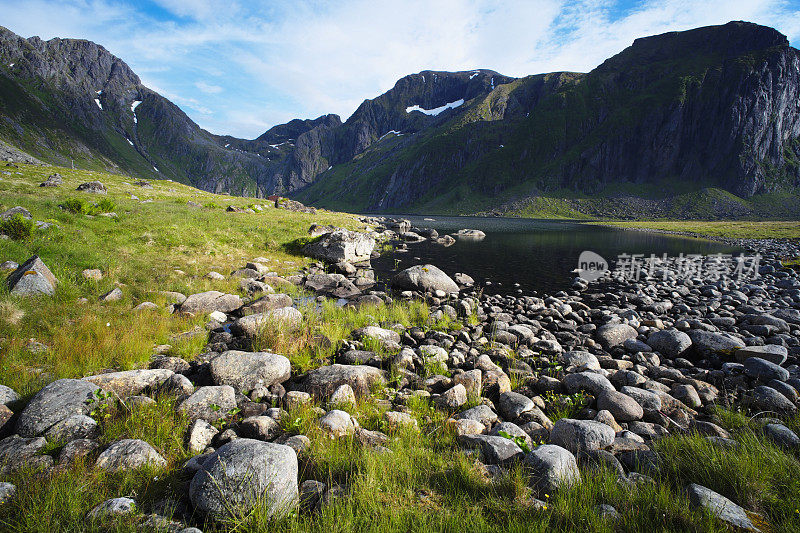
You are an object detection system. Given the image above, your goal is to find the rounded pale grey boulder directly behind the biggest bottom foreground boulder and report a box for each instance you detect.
[209,350,292,394]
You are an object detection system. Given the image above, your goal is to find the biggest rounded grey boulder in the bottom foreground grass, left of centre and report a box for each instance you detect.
[189,439,299,519]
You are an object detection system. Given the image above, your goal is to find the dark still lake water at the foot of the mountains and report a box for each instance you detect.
[372,216,741,294]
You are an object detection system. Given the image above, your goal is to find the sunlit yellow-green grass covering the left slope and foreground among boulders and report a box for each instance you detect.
[0,166,800,533]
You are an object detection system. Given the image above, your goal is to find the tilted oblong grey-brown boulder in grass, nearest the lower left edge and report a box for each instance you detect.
[17,379,100,437]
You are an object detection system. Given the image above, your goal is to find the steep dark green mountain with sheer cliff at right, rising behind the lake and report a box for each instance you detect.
[299,22,800,210]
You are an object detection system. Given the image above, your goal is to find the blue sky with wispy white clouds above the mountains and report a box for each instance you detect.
[0,0,800,138]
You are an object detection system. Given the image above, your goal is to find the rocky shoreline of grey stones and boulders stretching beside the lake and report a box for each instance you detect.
[0,214,800,533]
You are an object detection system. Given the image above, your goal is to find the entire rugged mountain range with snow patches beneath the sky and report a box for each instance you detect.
[0,22,800,212]
